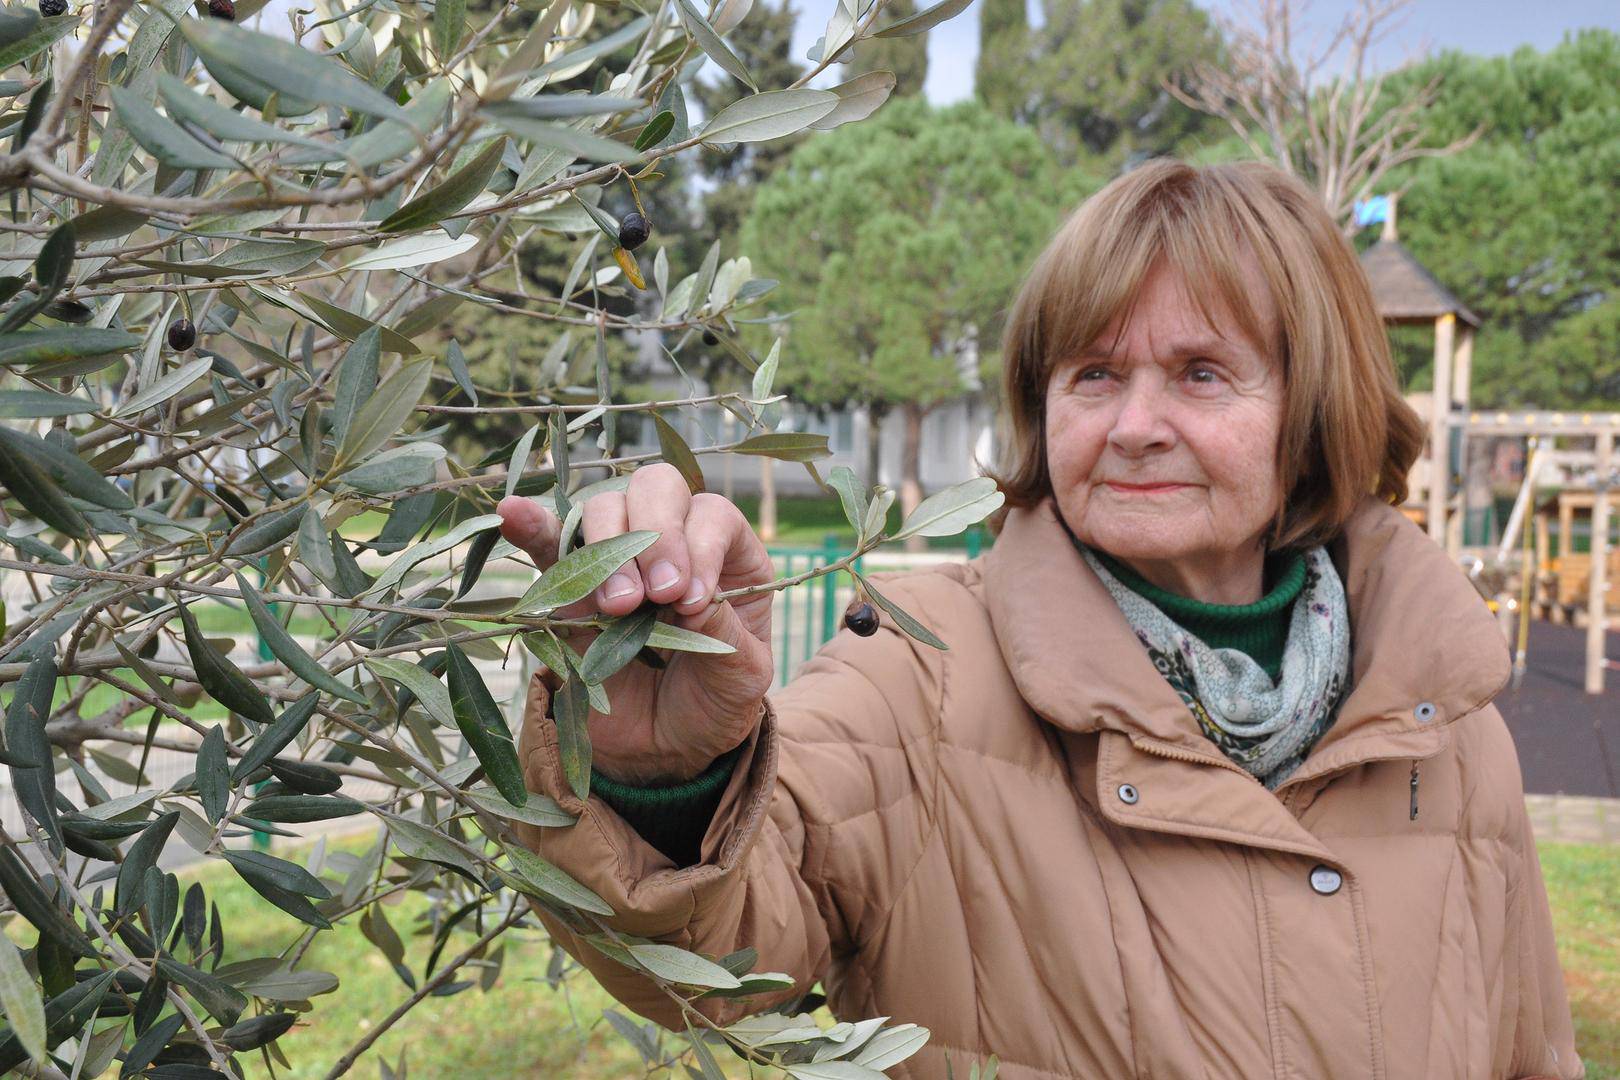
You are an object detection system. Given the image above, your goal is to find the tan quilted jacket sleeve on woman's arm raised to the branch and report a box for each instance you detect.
[514,575,943,1030]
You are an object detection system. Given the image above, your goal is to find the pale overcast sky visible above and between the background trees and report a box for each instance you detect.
[794,0,1620,104]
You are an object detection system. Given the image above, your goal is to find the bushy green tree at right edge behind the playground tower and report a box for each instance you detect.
[1385,29,1620,408]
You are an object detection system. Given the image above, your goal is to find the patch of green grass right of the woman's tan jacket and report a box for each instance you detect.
[1537,844,1620,1080]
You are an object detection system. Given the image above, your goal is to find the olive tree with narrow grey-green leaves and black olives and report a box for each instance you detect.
[0,0,1000,1078]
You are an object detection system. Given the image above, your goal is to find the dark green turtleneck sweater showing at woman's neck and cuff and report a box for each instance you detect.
[591,547,1306,866]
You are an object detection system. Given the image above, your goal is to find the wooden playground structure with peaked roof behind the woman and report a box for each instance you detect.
[1361,207,1620,695]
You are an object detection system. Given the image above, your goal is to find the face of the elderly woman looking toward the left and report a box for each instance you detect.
[1047,266,1285,604]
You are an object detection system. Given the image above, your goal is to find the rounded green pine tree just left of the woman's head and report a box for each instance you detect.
[742,99,1084,544]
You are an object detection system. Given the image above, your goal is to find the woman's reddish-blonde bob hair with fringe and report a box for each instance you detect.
[990,159,1426,551]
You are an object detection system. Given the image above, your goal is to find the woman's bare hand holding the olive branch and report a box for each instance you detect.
[497,463,776,785]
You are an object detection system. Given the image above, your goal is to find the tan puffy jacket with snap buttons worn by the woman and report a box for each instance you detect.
[522,495,1584,1080]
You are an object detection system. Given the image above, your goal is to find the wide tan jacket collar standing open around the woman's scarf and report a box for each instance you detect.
[985,495,1513,782]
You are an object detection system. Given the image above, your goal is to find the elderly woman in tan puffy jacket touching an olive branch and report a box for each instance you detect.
[501,162,1584,1080]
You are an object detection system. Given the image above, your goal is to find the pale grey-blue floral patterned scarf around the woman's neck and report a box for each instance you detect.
[1076,542,1349,792]
